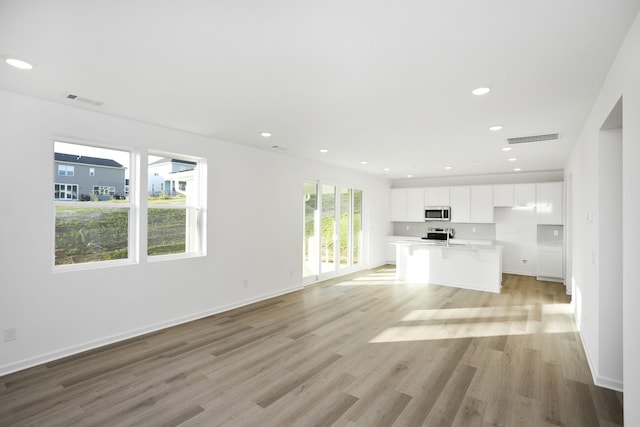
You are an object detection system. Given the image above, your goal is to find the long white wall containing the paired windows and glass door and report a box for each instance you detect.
[0,91,391,375]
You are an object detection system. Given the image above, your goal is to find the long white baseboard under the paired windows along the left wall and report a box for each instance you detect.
[0,286,303,376]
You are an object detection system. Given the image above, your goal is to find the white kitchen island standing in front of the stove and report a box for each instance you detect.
[394,240,502,293]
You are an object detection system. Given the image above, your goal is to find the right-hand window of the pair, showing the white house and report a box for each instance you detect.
[147,153,203,257]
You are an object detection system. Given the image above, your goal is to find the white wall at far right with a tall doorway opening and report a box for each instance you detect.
[565,8,640,425]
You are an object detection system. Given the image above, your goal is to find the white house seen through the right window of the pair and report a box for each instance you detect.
[147,158,197,196]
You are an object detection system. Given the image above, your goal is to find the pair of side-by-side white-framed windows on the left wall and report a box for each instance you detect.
[53,142,204,269]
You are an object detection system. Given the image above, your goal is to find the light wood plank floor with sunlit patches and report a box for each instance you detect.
[0,266,622,427]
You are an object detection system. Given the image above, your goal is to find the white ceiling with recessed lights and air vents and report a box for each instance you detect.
[0,0,640,178]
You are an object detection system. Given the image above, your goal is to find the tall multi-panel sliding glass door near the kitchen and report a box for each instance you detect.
[302,183,362,283]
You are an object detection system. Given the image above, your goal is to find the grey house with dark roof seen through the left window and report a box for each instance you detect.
[53,153,127,200]
